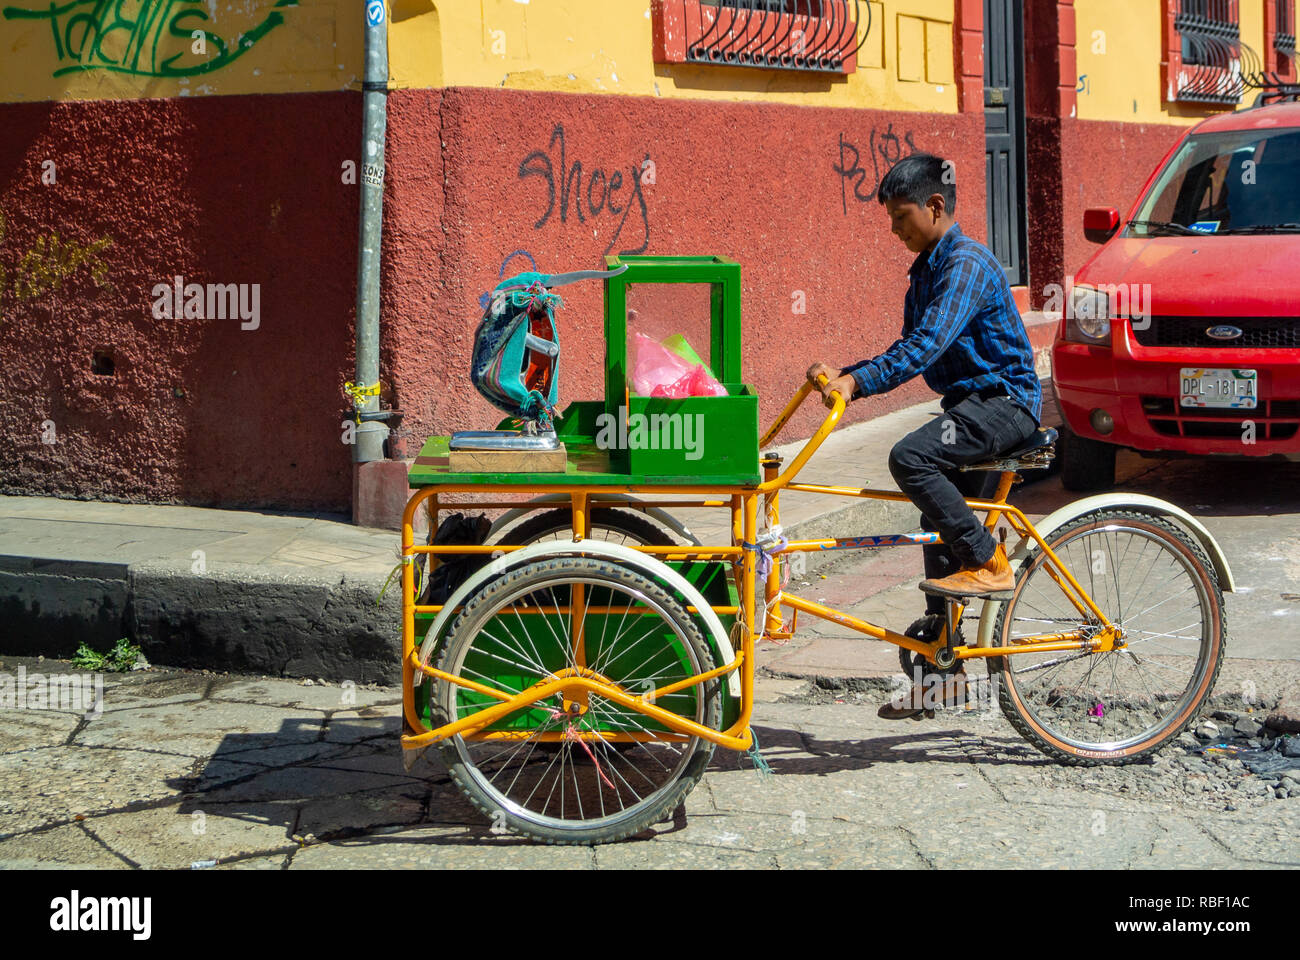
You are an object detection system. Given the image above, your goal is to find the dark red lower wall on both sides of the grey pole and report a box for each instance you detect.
[0,88,985,510]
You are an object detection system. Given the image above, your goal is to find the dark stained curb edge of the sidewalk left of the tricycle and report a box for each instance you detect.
[0,555,402,684]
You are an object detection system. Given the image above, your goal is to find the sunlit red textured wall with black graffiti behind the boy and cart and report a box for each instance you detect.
[384,88,985,455]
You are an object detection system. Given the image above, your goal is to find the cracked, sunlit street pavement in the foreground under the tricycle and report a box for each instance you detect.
[0,657,1300,870]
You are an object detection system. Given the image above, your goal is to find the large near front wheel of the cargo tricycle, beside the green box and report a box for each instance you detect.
[432,548,723,844]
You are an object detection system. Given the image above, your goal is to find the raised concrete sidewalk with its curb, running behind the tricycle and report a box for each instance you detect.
[0,390,1040,683]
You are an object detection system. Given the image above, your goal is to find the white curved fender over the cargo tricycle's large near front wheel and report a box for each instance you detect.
[413,540,740,697]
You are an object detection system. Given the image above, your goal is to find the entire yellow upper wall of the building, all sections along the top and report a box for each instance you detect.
[0,0,1300,117]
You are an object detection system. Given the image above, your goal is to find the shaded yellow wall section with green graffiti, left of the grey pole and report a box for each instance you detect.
[0,0,366,103]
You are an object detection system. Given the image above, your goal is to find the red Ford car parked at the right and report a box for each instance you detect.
[1052,94,1300,490]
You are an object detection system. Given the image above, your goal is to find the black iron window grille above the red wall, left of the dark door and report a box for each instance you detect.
[685,0,871,73]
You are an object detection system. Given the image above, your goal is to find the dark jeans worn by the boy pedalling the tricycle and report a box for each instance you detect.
[889,393,1039,614]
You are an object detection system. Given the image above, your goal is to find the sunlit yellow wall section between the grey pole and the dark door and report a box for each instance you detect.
[389,0,957,113]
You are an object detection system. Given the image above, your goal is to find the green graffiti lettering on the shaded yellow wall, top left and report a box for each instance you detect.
[4,0,298,77]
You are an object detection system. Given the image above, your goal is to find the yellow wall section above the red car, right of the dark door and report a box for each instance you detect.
[1074,0,1300,125]
